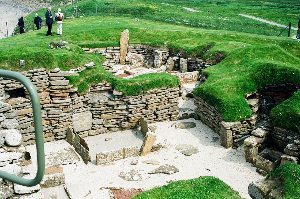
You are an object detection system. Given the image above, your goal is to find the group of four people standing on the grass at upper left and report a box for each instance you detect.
[18,7,64,36]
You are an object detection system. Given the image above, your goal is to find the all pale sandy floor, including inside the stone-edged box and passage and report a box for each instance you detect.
[25,83,264,199]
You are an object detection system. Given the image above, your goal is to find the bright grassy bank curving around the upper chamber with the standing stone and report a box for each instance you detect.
[0,0,300,129]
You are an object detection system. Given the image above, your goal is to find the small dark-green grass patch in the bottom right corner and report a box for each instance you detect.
[269,163,300,199]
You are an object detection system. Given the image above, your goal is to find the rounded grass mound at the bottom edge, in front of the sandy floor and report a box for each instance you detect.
[134,177,241,199]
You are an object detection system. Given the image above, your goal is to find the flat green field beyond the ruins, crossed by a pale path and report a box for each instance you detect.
[45,0,300,36]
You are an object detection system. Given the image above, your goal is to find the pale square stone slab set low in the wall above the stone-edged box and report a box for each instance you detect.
[72,112,93,132]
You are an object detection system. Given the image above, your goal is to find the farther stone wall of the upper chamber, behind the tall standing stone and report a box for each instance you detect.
[84,45,210,73]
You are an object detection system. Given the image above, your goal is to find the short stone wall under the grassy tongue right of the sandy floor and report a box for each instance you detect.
[195,95,258,148]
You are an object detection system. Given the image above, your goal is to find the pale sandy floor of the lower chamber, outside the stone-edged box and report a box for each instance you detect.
[27,119,263,199]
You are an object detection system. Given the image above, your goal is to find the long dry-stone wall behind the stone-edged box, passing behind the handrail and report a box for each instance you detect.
[0,69,180,145]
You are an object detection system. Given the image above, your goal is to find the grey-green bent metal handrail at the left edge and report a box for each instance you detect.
[0,69,45,187]
